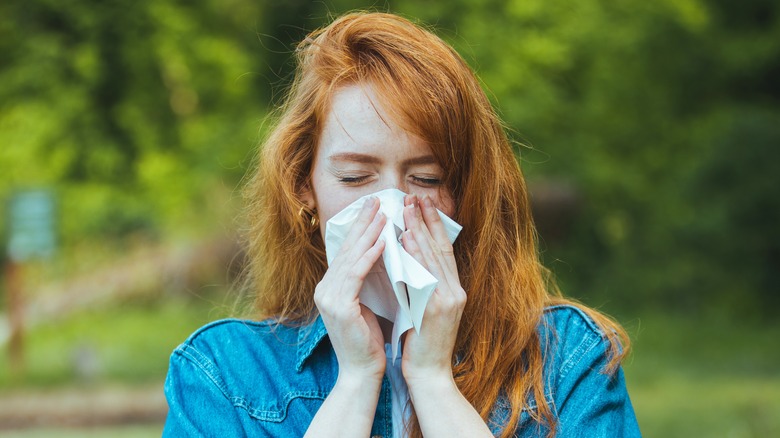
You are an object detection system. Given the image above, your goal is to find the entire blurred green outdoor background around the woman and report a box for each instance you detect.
[0,0,780,437]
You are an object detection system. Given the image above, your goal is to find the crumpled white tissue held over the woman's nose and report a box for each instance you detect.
[325,189,463,361]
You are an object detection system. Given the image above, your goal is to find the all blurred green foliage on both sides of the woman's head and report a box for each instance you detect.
[0,0,780,316]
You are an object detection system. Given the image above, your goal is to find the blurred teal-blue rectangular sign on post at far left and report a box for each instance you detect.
[8,190,56,262]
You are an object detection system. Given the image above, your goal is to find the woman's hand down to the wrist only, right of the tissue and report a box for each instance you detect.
[401,195,466,384]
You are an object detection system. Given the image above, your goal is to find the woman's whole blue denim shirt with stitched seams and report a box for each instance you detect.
[163,306,640,438]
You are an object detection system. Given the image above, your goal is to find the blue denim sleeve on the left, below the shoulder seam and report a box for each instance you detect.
[162,345,246,437]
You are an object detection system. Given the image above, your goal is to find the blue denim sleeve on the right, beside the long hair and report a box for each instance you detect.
[555,332,641,437]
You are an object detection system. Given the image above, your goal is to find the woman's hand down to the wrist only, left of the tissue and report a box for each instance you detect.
[314,197,387,382]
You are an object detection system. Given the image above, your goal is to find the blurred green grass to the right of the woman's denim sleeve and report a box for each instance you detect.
[624,313,780,438]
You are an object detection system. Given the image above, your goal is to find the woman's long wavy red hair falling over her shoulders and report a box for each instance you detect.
[245,13,628,436]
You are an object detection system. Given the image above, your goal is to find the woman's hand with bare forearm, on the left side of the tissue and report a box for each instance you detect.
[306,197,387,437]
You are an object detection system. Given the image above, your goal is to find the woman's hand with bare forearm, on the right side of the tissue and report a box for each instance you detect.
[401,195,493,437]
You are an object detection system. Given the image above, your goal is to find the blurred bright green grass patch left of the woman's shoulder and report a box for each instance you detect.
[0,290,232,389]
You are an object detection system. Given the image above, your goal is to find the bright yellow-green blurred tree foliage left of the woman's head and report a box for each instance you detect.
[0,0,266,240]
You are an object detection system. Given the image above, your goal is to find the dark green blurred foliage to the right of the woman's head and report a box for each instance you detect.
[390,0,780,317]
